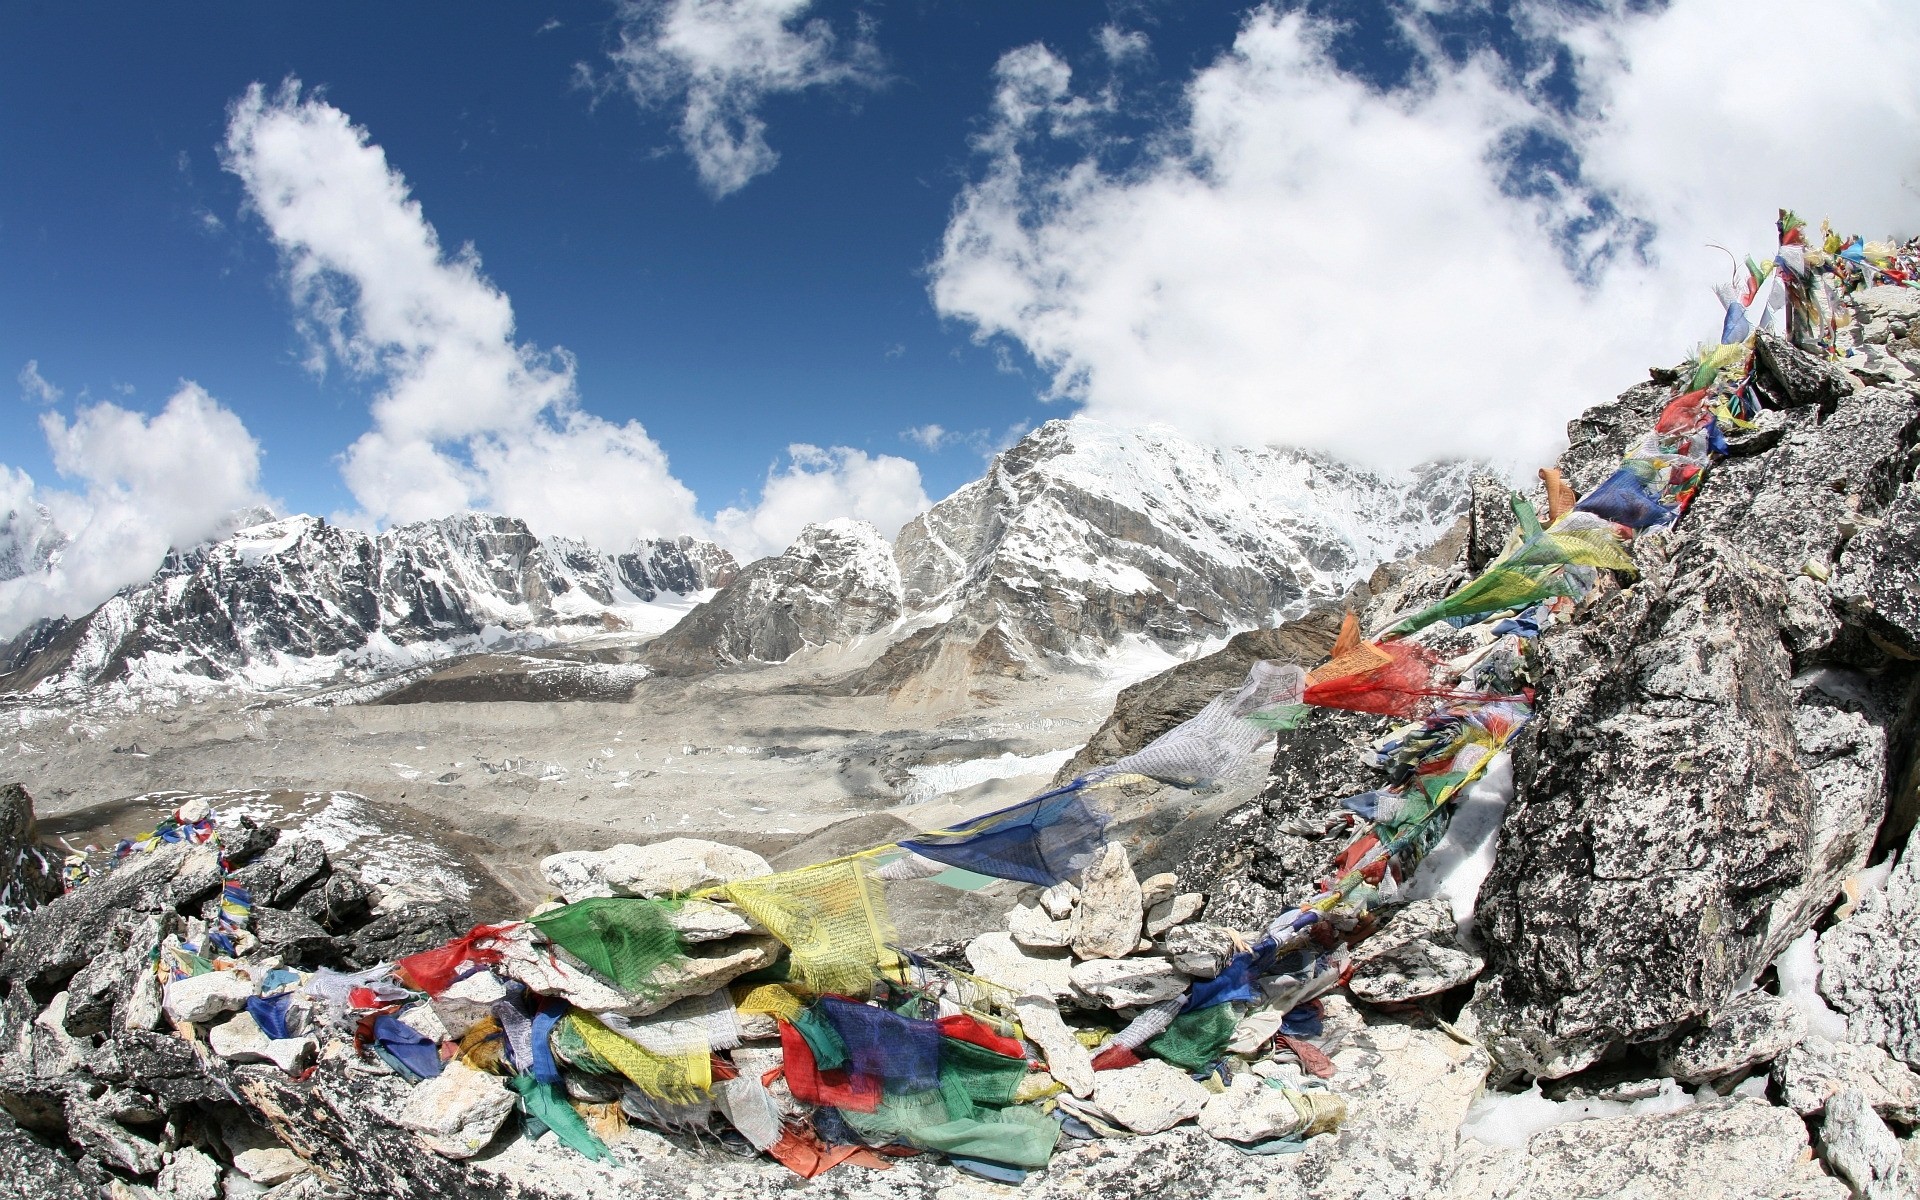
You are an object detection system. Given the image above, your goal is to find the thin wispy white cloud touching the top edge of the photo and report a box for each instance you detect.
[611,0,879,198]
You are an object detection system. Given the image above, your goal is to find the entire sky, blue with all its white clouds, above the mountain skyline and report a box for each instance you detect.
[0,0,1920,637]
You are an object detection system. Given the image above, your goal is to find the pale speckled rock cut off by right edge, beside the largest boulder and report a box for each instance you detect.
[1820,821,1920,1068]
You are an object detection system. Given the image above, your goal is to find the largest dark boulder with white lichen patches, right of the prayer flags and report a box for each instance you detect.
[1463,534,1885,1077]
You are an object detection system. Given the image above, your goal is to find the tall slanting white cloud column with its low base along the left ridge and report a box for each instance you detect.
[225,81,925,555]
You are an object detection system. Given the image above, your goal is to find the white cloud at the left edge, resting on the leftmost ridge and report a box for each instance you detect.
[0,382,269,637]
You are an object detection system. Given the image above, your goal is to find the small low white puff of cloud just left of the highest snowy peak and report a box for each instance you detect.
[714,444,931,563]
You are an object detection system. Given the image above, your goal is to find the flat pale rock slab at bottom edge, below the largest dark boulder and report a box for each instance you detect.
[1442,1098,1847,1200]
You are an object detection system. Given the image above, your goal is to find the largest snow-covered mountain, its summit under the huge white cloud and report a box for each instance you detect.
[870,419,1473,687]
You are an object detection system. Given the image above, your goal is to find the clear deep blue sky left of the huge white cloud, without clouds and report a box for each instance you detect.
[0,2,1238,513]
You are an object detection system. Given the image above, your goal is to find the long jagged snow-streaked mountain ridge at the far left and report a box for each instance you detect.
[0,513,735,693]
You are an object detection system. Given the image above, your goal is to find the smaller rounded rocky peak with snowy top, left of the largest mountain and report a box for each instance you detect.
[645,518,900,674]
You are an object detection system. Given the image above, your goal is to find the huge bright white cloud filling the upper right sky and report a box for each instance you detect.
[931,0,1920,478]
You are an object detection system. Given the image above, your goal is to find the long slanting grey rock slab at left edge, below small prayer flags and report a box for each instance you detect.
[0,845,223,995]
